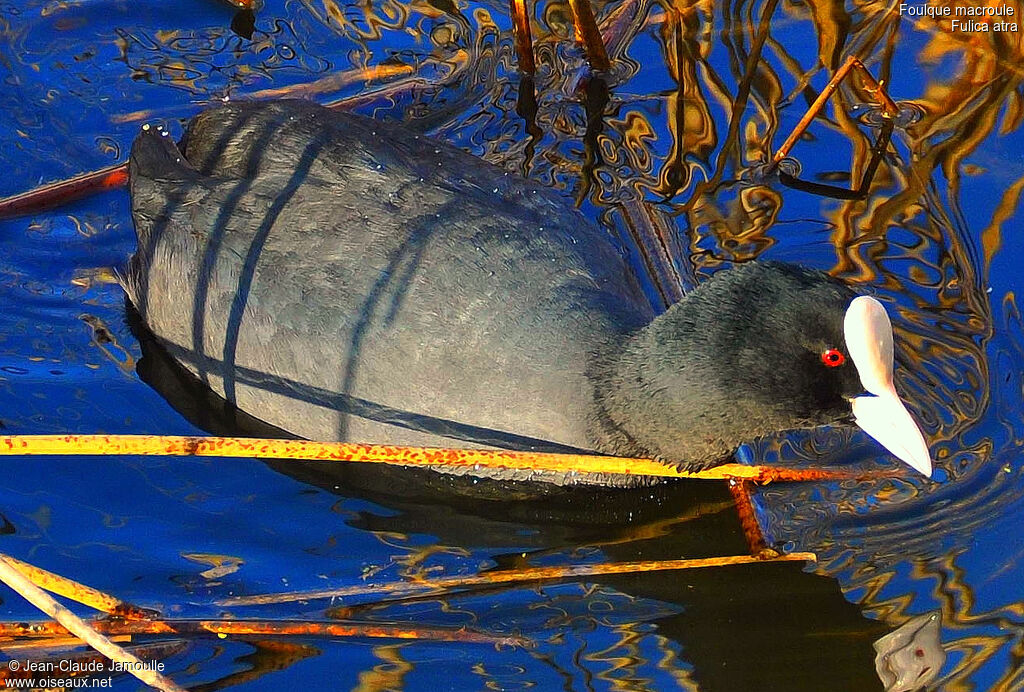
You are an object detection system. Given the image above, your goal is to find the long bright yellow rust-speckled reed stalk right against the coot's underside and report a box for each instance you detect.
[0,435,899,482]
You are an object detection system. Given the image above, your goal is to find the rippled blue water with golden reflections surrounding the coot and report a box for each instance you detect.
[0,0,1024,690]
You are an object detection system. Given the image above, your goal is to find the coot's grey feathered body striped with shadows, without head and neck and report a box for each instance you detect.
[126,101,652,462]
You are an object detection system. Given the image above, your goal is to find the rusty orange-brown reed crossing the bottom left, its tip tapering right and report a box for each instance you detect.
[0,618,530,646]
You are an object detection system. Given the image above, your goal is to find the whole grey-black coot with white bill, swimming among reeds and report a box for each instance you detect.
[123,100,931,483]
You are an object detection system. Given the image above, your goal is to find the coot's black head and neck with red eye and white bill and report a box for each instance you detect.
[604,262,931,475]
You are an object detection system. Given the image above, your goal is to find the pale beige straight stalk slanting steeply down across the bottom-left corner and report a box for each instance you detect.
[0,555,184,692]
